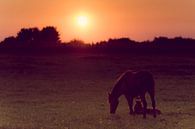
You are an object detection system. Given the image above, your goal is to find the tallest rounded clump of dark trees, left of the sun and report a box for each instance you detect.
[1,26,61,47]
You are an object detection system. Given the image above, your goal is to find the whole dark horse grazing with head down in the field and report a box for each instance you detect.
[108,71,156,118]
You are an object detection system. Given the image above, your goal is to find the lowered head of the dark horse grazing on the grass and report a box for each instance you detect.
[108,93,119,114]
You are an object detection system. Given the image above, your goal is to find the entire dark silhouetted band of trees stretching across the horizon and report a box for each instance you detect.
[0,26,195,54]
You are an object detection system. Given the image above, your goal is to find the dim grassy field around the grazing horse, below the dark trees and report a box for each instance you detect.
[0,54,195,129]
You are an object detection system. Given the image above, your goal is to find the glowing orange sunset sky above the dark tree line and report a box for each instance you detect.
[0,0,195,42]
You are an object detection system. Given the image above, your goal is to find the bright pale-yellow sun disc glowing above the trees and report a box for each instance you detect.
[76,15,89,28]
